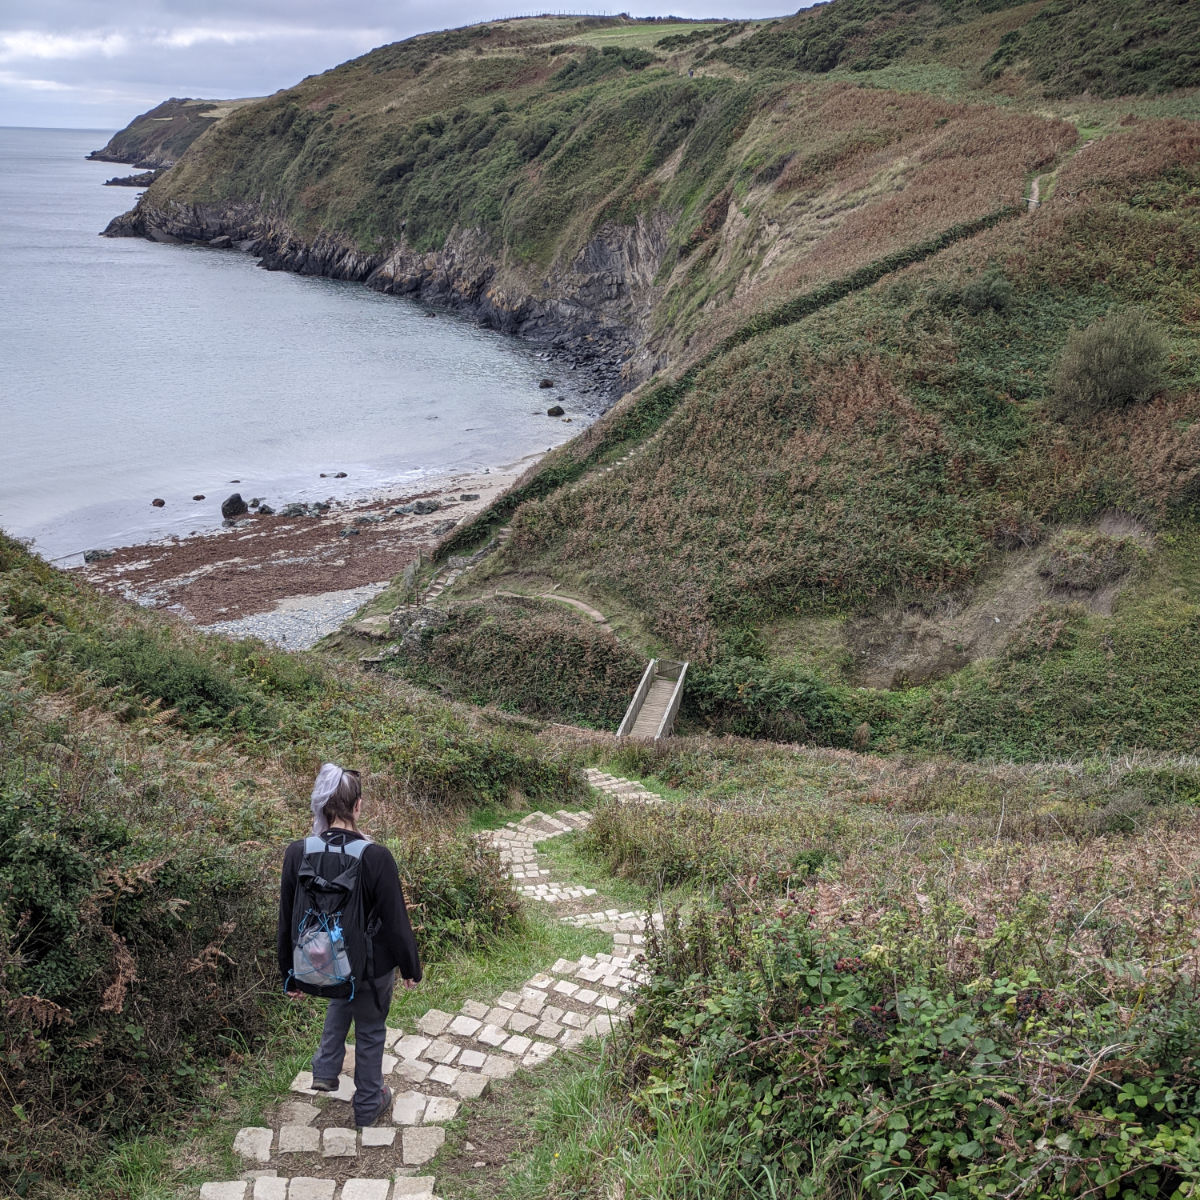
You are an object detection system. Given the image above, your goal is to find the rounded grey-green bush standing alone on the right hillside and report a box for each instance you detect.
[1051,310,1168,418]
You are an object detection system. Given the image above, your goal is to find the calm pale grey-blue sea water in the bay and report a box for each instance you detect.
[0,128,583,558]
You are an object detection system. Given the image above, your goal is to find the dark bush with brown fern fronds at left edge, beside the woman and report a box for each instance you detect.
[0,742,275,1194]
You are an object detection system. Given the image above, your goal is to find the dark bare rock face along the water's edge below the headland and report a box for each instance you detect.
[104,198,671,401]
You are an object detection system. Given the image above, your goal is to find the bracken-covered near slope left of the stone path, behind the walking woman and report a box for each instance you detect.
[0,535,581,1195]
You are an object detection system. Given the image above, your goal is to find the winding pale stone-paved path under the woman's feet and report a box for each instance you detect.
[200,769,661,1200]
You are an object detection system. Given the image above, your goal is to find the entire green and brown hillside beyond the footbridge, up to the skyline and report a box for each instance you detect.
[114,9,1200,757]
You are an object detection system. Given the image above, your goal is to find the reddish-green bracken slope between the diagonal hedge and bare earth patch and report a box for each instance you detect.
[505,130,1200,638]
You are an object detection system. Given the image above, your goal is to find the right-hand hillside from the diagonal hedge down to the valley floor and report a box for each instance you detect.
[439,122,1200,757]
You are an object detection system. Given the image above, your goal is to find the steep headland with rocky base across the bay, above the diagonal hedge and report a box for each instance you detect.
[100,11,1076,400]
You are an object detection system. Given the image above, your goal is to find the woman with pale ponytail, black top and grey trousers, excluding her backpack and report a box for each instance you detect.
[277,762,421,1126]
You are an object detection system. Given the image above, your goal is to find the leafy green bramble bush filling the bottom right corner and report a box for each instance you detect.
[620,898,1200,1200]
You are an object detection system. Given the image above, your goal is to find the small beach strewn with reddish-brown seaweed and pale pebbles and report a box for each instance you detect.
[71,452,528,628]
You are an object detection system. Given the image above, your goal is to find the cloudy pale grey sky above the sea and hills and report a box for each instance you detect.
[0,0,800,132]
